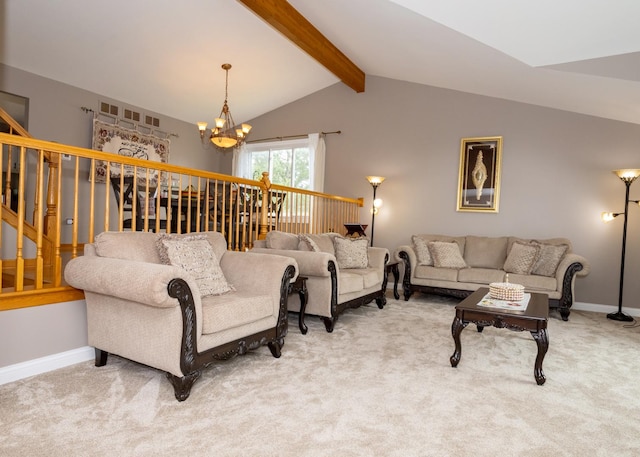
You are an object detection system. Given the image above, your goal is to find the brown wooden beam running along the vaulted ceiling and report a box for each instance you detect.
[238,0,365,92]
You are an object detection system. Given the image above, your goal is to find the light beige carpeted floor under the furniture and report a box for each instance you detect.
[0,294,640,457]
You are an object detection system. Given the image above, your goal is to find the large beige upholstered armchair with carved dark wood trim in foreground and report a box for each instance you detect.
[65,232,297,401]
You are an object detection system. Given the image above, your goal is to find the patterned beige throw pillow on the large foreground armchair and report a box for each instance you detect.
[158,235,234,297]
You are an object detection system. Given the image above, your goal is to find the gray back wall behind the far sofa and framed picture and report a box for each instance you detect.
[245,77,640,307]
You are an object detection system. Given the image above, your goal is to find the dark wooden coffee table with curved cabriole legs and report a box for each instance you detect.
[449,287,549,386]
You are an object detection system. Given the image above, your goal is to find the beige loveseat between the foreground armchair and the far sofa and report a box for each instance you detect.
[251,231,389,332]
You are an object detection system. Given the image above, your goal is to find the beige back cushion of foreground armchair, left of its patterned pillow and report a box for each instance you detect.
[94,232,162,263]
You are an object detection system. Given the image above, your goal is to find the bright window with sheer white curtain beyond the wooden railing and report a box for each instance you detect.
[233,134,324,192]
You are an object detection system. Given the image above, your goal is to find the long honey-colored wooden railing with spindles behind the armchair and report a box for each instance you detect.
[0,133,363,312]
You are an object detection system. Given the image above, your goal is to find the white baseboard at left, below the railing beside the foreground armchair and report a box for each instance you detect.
[0,346,95,385]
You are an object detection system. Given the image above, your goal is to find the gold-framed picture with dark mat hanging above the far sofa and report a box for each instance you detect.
[457,136,502,213]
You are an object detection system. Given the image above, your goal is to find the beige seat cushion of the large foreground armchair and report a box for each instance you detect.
[202,291,273,335]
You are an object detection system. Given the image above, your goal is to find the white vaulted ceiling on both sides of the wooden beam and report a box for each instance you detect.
[0,0,640,124]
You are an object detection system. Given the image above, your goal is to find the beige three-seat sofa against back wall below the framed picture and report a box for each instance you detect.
[395,234,590,321]
